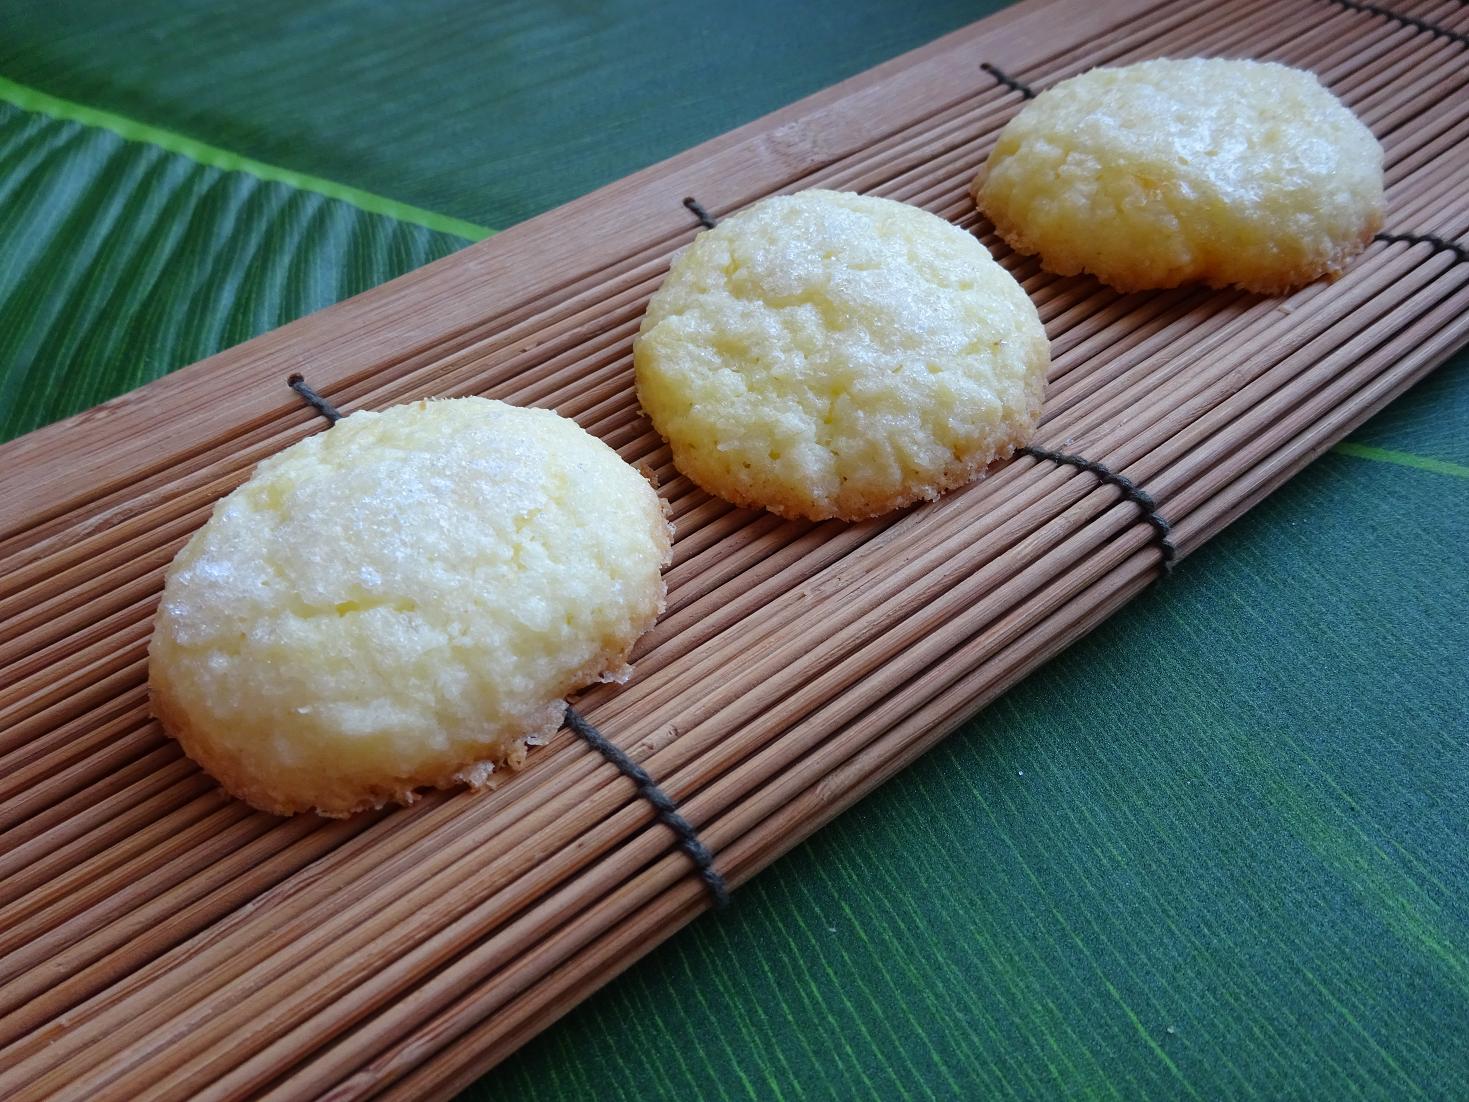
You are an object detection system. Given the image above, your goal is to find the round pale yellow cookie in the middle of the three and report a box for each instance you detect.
[633,190,1050,520]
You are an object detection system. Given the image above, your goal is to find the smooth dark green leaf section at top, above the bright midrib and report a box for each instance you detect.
[0,0,1002,229]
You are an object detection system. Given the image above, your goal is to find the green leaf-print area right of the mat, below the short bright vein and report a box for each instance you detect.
[484,455,1469,1102]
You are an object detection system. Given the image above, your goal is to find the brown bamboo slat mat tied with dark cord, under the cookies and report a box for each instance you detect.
[0,0,1469,1098]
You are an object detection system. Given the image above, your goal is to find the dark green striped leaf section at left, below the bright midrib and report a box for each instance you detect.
[0,100,466,439]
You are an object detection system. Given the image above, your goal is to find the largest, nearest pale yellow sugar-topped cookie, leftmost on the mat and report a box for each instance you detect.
[148,398,671,815]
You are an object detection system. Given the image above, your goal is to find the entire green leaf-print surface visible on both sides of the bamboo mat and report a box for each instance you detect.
[0,0,1469,1099]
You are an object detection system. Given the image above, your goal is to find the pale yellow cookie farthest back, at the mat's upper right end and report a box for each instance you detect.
[972,57,1382,294]
